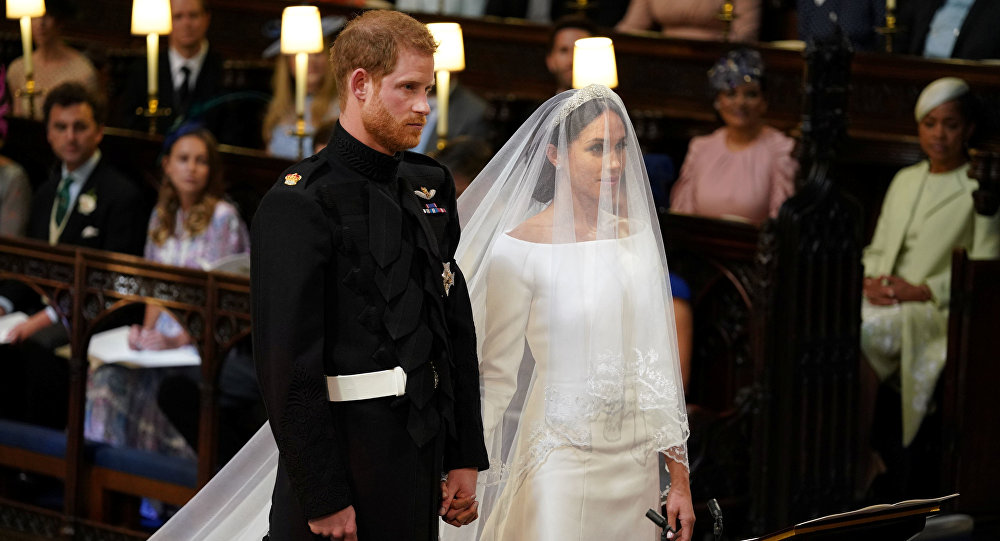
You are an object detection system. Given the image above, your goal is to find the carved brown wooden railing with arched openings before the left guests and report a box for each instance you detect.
[0,237,250,532]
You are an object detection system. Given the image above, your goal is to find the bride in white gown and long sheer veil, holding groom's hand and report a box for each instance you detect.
[153,86,694,541]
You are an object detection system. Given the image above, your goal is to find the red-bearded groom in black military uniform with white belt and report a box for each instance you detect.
[251,11,488,541]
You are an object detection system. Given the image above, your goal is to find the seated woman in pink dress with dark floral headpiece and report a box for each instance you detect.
[670,49,798,224]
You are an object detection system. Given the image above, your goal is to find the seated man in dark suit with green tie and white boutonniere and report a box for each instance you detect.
[0,83,146,427]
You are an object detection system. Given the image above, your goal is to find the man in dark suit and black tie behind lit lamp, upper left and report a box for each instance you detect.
[116,0,241,144]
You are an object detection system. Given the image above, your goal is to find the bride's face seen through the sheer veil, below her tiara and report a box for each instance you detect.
[568,111,625,201]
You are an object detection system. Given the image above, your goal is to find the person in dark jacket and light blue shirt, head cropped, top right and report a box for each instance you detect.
[896,0,1000,60]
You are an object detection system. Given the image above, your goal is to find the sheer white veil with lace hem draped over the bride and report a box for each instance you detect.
[442,85,688,539]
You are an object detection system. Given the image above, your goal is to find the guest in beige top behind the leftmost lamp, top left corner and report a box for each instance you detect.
[7,0,97,120]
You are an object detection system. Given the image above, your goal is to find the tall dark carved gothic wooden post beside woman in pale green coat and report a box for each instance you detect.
[750,34,862,533]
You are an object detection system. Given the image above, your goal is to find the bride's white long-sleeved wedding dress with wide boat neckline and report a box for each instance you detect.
[470,231,681,540]
